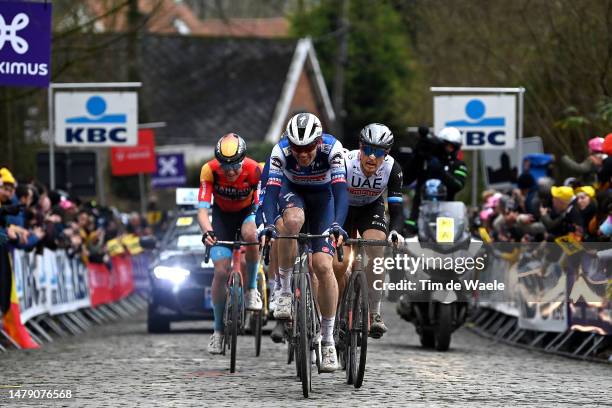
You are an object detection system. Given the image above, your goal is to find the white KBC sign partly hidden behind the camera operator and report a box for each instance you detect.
[434,95,516,150]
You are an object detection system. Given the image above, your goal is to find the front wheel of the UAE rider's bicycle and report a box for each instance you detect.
[350,271,370,388]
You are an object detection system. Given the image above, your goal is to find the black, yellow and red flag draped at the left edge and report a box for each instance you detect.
[0,245,40,349]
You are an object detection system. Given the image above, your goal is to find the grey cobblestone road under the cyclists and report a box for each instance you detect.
[0,304,612,407]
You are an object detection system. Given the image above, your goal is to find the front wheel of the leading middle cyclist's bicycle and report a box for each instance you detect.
[297,273,312,398]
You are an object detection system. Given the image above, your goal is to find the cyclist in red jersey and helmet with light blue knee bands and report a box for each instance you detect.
[198,133,262,354]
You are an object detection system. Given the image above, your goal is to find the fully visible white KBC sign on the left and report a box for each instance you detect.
[54,92,138,147]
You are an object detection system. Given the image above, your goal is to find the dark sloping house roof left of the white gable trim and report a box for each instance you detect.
[140,35,297,144]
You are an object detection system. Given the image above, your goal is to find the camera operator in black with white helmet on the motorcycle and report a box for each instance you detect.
[404,127,468,235]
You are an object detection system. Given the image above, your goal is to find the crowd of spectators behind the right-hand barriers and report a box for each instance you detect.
[475,133,612,242]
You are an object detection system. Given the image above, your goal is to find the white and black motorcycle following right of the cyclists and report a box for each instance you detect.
[397,201,482,351]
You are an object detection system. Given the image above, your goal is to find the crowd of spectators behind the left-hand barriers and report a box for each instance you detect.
[0,167,151,263]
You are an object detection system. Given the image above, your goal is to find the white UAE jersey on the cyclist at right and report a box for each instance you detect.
[344,150,402,207]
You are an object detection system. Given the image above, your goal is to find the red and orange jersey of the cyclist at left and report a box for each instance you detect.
[198,157,261,212]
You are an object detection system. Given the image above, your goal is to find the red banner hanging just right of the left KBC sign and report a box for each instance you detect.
[111,129,157,176]
